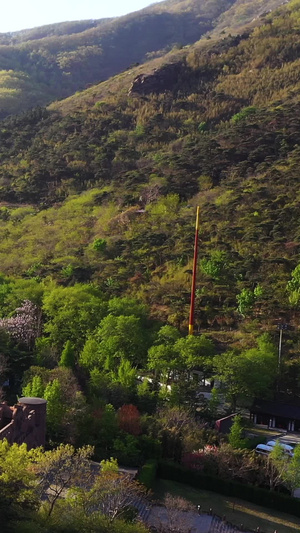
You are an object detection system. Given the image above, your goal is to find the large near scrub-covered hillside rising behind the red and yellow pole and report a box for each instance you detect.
[0,2,300,354]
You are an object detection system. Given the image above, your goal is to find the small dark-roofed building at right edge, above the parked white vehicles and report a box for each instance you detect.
[250,400,300,432]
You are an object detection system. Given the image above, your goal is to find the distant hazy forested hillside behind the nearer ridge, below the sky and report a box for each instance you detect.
[0,0,281,118]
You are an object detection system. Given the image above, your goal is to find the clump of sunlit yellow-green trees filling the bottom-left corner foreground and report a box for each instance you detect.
[0,439,146,533]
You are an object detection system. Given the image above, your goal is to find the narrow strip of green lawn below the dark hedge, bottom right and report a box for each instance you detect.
[154,479,300,533]
